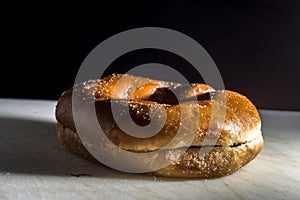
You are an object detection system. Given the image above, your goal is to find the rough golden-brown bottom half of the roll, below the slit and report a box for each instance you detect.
[57,123,263,178]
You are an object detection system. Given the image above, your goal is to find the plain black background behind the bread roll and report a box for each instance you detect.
[0,0,300,110]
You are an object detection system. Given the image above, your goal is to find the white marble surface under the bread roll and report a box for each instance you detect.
[0,99,300,199]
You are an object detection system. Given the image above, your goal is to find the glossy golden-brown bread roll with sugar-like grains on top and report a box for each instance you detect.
[56,74,263,178]
